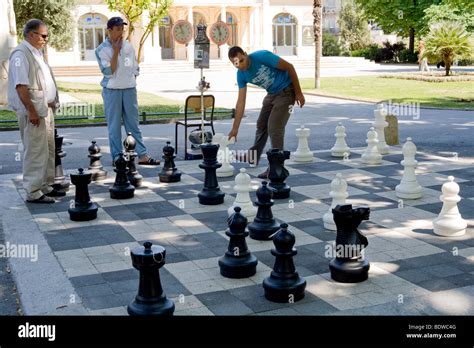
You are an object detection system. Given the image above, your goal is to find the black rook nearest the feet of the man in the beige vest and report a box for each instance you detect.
[68,168,98,221]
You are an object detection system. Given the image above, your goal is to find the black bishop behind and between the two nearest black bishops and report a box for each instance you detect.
[247,181,279,240]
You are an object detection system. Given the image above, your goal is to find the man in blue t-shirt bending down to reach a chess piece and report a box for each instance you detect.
[229,46,305,179]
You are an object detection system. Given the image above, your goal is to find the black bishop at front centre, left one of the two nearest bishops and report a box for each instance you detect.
[219,207,258,278]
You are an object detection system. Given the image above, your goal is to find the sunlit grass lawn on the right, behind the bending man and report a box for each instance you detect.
[301,76,474,109]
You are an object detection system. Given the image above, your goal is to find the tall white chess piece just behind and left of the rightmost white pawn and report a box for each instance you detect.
[395,138,423,199]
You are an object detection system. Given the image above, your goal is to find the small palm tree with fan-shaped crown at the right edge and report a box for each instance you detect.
[424,22,474,76]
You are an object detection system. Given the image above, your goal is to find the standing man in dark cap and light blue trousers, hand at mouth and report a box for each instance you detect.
[95,17,160,165]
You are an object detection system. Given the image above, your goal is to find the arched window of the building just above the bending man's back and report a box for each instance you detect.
[273,13,297,56]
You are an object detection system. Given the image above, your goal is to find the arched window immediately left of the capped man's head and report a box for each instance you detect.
[77,13,107,60]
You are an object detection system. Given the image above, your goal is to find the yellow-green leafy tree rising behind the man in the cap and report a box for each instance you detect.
[106,0,173,62]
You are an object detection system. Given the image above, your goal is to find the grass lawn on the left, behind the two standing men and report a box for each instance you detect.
[0,81,230,127]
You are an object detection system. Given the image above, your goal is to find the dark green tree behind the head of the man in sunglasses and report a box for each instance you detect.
[13,0,76,58]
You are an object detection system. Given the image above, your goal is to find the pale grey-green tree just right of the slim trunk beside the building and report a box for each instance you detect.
[337,1,370,51]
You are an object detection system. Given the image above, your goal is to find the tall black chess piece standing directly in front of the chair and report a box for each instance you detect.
[198,139,225,205]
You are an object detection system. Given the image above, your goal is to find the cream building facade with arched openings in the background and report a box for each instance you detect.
[49,0,348,66]
